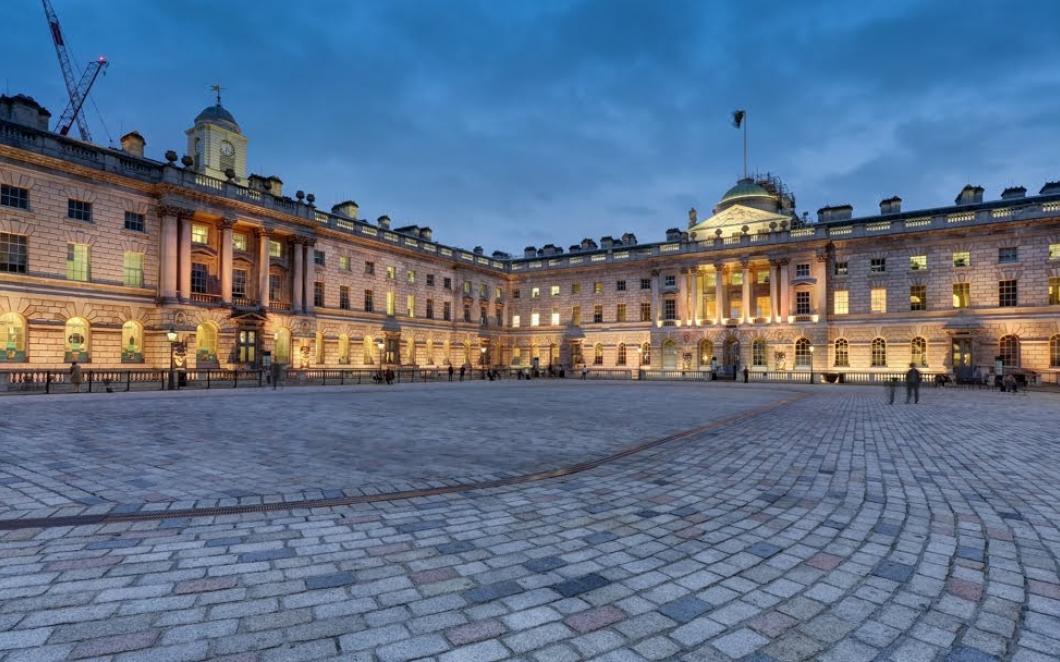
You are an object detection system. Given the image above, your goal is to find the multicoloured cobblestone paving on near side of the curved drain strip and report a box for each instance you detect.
[0,384,1060,662]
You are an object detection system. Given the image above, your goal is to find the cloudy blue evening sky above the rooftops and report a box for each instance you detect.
[8,0,1060,254]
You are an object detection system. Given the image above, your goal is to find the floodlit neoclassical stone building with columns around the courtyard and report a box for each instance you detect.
[0,96,1060,381]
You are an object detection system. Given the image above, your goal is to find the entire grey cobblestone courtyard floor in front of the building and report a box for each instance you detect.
[0,381,1060,662]
